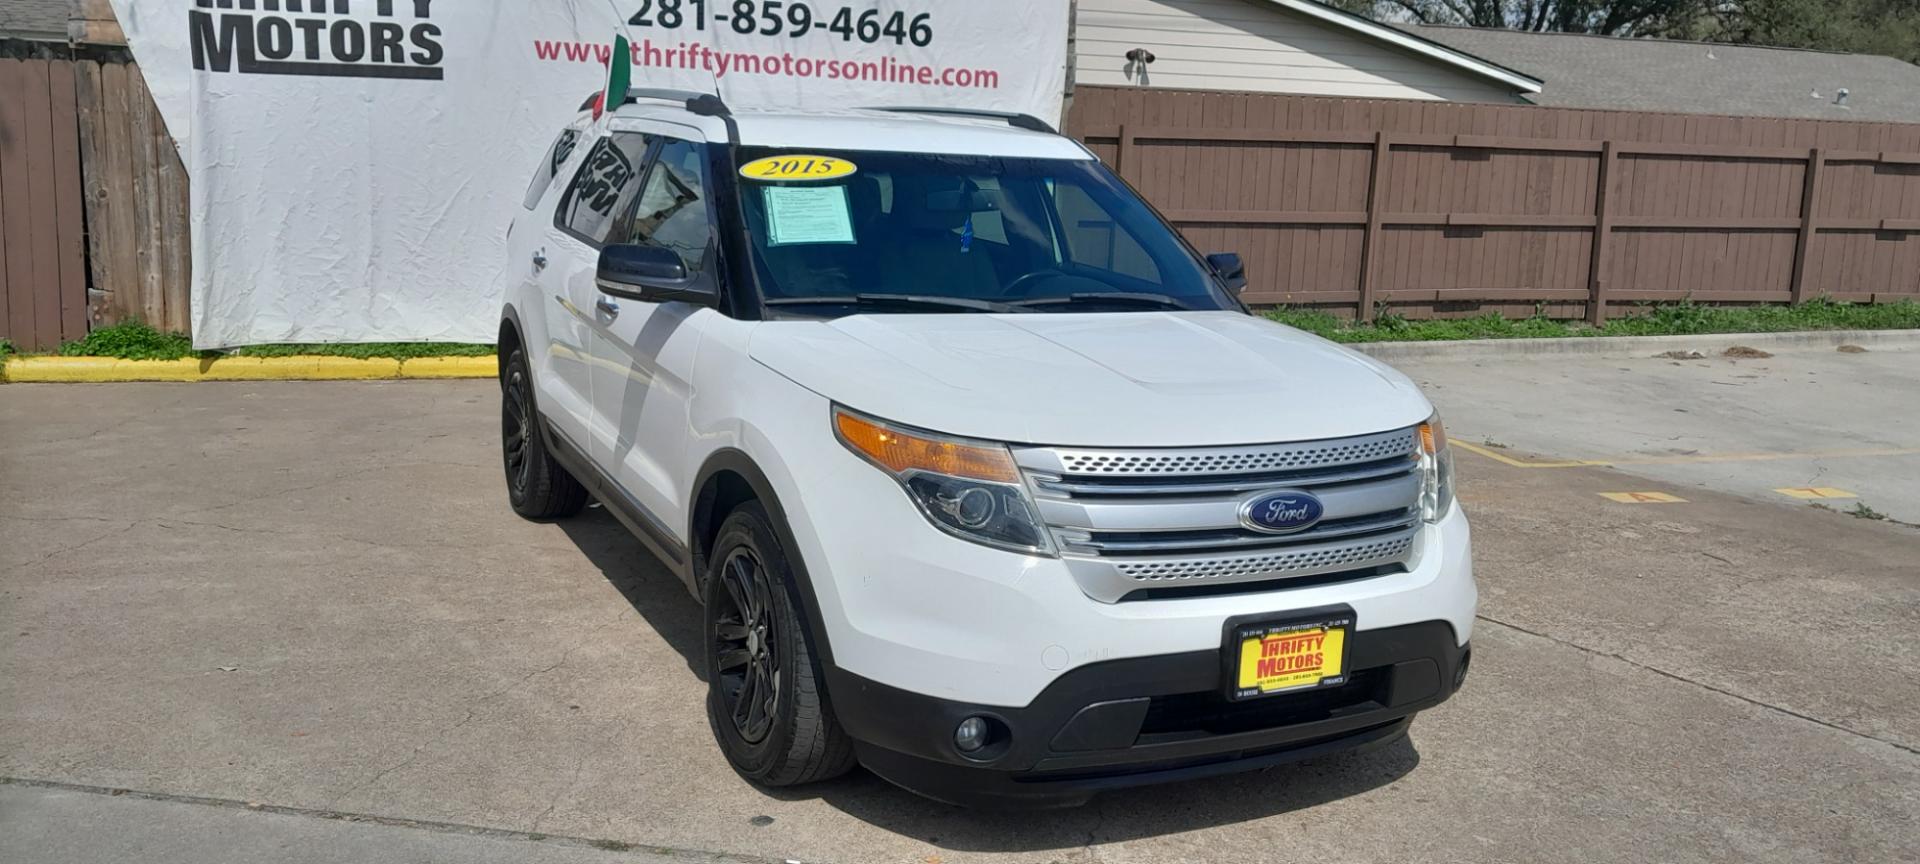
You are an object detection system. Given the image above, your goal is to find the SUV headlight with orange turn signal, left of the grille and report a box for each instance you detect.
[833,405,1054,555]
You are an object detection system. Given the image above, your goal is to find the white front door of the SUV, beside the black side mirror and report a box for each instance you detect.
[589,127,720,547]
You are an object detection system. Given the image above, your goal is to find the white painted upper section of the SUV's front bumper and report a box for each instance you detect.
[783,430,1478,707]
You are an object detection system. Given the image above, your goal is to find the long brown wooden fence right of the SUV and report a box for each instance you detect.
[1068,86,1920,323]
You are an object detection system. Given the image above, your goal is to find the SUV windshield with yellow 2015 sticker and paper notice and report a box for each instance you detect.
[739,148,1236,315]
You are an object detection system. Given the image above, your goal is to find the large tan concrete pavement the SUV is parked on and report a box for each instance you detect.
[0,380,1920,864]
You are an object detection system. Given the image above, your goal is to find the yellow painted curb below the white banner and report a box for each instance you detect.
[0,357,497,384]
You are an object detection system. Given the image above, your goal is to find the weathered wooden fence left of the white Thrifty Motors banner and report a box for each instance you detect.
[0,42,192,351]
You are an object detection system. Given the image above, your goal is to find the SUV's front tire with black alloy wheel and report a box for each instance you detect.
[703,501,854,787]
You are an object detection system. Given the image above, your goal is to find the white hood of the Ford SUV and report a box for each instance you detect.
[751,311,1432,447]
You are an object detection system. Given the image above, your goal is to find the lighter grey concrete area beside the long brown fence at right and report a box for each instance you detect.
[1392,338,1920,522]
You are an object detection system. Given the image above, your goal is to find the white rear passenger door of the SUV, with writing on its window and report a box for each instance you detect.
[530,131,653,455]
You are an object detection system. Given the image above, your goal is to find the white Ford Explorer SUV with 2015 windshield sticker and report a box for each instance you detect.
[499,90,1476,804]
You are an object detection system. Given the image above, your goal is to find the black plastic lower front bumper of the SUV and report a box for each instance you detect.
[828,620,1471,806]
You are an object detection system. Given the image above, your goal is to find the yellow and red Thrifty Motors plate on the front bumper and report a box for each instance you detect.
[1227,609,1354,699]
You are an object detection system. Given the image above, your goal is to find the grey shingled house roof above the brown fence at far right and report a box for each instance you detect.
[1402,25,1920,123]
